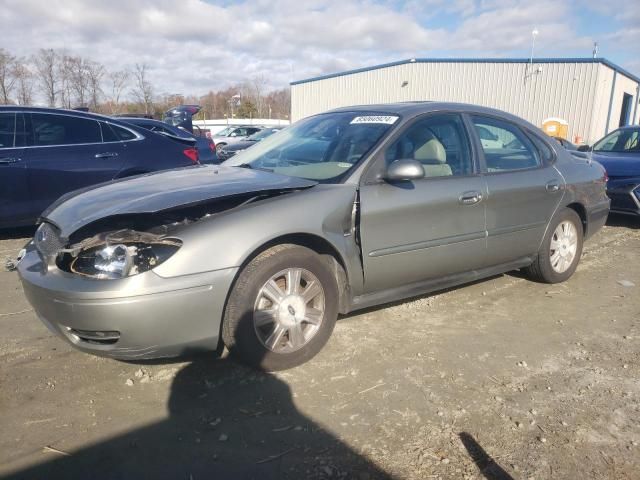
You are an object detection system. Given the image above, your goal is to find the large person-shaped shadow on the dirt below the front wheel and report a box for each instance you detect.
[5,356,393,480]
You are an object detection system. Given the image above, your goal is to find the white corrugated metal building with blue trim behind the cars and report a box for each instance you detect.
[291,58,640,143]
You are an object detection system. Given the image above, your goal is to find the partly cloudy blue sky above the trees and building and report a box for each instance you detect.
[0,0,640,95]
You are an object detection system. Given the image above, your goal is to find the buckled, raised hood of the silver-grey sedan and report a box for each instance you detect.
[41,165,317,238]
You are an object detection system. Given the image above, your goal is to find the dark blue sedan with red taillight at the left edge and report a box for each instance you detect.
[0,106,198,228]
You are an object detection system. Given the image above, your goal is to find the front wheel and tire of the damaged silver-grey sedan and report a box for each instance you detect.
[222,244,339,371]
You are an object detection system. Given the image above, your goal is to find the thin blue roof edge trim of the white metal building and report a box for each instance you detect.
[291,57,640,85]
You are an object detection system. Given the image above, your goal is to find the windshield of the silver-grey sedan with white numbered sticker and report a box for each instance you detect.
[225,112,398,182]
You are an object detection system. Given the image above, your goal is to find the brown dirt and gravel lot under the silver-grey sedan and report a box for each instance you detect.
[0,218,640,480]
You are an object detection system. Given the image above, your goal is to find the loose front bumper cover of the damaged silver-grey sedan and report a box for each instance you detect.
[18,248,238,360]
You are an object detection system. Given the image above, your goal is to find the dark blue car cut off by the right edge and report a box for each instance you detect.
[579,125,640,216]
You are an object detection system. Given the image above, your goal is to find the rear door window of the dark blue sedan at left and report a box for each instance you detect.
[31,113,102,146]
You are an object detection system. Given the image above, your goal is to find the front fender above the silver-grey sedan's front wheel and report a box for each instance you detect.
[154,184,362,291]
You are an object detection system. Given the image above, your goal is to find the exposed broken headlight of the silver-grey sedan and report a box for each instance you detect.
[69,239,180,279]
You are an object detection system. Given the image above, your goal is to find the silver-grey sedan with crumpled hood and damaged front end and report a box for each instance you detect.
[18,102,609,370]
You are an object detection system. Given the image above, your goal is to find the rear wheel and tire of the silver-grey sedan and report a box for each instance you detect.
[524,208,583,283]
